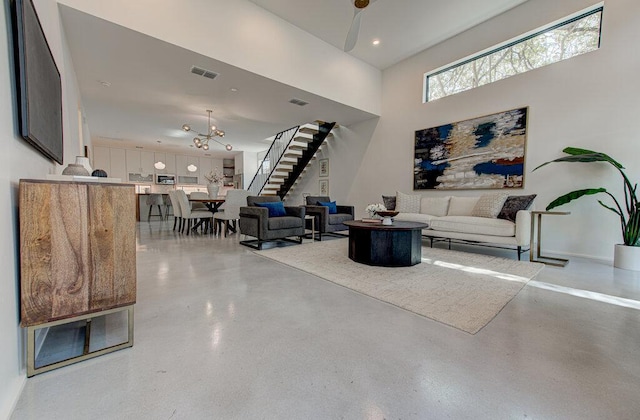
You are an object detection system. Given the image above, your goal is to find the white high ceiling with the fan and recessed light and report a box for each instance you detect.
[250,0,526,69]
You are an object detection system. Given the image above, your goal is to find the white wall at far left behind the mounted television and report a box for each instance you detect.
[0,0,86,418]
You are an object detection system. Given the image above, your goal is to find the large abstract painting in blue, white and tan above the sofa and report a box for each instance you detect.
[413,107,528,190]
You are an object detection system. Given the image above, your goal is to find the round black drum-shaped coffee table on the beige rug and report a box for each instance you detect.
[344,220,427,267]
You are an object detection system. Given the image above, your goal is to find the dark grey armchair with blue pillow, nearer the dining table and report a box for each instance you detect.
[240,196,305,249]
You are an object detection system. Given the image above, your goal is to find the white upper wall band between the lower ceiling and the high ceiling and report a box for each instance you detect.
[60,0,381,115]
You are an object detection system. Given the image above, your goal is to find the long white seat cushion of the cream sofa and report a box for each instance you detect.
[429,216,516,236]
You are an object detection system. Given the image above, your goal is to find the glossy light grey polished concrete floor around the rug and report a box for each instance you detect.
[12,222,640,419]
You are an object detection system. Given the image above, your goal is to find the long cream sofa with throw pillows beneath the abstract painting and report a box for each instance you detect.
[394,192,535,259]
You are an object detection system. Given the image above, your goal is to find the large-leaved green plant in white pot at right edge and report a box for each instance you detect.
[534,147,640,270]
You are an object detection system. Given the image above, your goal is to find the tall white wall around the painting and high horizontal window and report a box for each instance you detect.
[348,0,640,260]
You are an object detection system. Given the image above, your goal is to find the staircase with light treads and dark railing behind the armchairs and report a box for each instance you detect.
[249,122,336,200]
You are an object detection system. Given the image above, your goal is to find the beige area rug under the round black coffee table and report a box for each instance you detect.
[255,239,544,334]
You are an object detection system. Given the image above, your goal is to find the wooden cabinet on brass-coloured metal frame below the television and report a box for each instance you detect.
[19,180,136,376]
